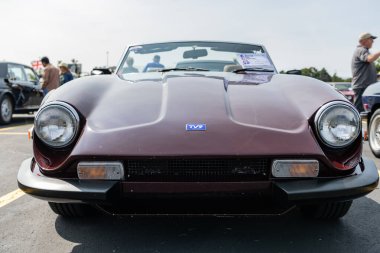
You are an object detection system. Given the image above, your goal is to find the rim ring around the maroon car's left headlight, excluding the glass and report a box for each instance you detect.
[34,101,80,148]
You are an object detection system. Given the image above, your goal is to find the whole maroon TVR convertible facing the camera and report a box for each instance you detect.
[18,41,379,219]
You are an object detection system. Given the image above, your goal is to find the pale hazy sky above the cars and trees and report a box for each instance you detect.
[0,0,380,77]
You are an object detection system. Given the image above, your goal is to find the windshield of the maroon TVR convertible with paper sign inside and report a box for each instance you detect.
[118,42,275,76]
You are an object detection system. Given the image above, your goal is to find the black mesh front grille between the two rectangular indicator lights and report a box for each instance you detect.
[126,158,270,182]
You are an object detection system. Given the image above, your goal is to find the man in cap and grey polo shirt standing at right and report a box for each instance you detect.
[351,33,380,112]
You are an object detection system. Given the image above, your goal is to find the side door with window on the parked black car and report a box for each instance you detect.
[8,63,35,110]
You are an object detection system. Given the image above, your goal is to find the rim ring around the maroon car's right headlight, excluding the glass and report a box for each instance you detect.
[314,101,361,149]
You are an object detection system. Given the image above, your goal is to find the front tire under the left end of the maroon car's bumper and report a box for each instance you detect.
[49,202,91,218]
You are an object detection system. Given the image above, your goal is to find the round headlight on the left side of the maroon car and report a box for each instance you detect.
[34,102,79,148]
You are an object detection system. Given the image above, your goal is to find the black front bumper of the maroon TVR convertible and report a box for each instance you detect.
[17,158,379,204]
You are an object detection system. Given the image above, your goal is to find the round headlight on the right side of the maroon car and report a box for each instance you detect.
[315,102,361,148]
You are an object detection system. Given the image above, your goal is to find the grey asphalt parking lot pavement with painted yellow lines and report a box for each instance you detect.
[0,115,380,253]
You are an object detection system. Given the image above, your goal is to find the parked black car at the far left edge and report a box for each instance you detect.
[0,62,44,124]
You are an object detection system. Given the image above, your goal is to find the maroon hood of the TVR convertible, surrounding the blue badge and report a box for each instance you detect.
[48,72,345,156]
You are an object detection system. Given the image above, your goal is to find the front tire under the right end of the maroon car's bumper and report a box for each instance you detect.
[300,200,352,220]
